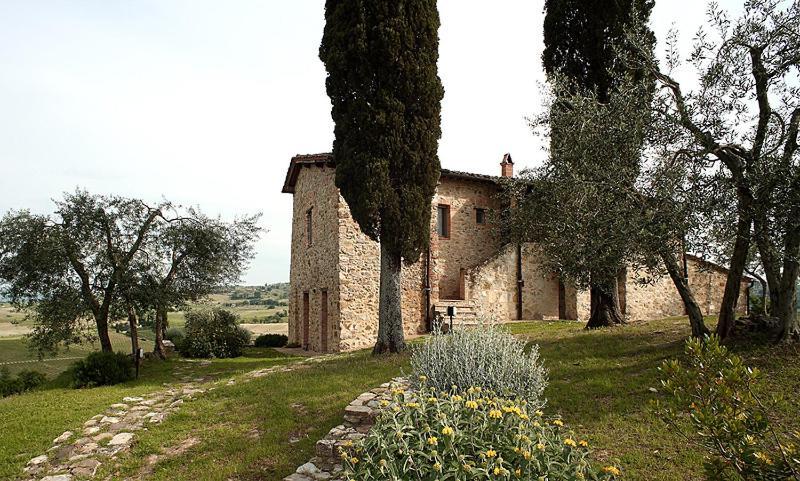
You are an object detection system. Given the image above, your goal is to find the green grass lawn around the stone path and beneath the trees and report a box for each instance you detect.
[0,319,800,481]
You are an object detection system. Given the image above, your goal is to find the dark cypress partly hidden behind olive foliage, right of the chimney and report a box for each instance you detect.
[542,0,655,328]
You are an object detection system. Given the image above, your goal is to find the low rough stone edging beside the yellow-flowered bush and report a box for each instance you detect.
[283,378,409,481]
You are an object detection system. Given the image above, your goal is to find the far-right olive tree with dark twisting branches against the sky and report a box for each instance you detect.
[629,0,800,339]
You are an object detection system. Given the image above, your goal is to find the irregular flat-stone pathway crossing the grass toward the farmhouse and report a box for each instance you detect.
[18,355,339,481]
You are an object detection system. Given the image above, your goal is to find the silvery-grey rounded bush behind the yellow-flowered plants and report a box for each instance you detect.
[411,326,547,409]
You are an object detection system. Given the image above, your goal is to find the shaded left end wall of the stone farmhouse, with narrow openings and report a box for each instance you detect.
[289,166,340,351]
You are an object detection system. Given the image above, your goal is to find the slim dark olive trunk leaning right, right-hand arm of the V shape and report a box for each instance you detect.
[717,192,753,340]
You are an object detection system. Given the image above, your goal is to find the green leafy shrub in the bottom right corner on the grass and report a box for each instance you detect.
[654,336,800,480]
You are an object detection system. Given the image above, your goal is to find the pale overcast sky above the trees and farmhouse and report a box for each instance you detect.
[0,0,741,284]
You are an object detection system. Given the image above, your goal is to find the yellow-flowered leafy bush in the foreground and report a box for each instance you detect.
[340,384,619,481]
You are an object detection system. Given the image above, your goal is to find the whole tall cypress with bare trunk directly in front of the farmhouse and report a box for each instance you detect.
[320,0,444,354]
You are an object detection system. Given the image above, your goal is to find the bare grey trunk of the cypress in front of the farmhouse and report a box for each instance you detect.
[372,243,406,354]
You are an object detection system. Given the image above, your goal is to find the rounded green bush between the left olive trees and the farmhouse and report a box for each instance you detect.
[180,308,250,358]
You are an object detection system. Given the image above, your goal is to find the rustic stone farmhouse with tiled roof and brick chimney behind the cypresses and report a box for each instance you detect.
[283,154,749,352]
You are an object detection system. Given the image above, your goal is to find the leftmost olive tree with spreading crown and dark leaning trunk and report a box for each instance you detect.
[0,190,169,353]
